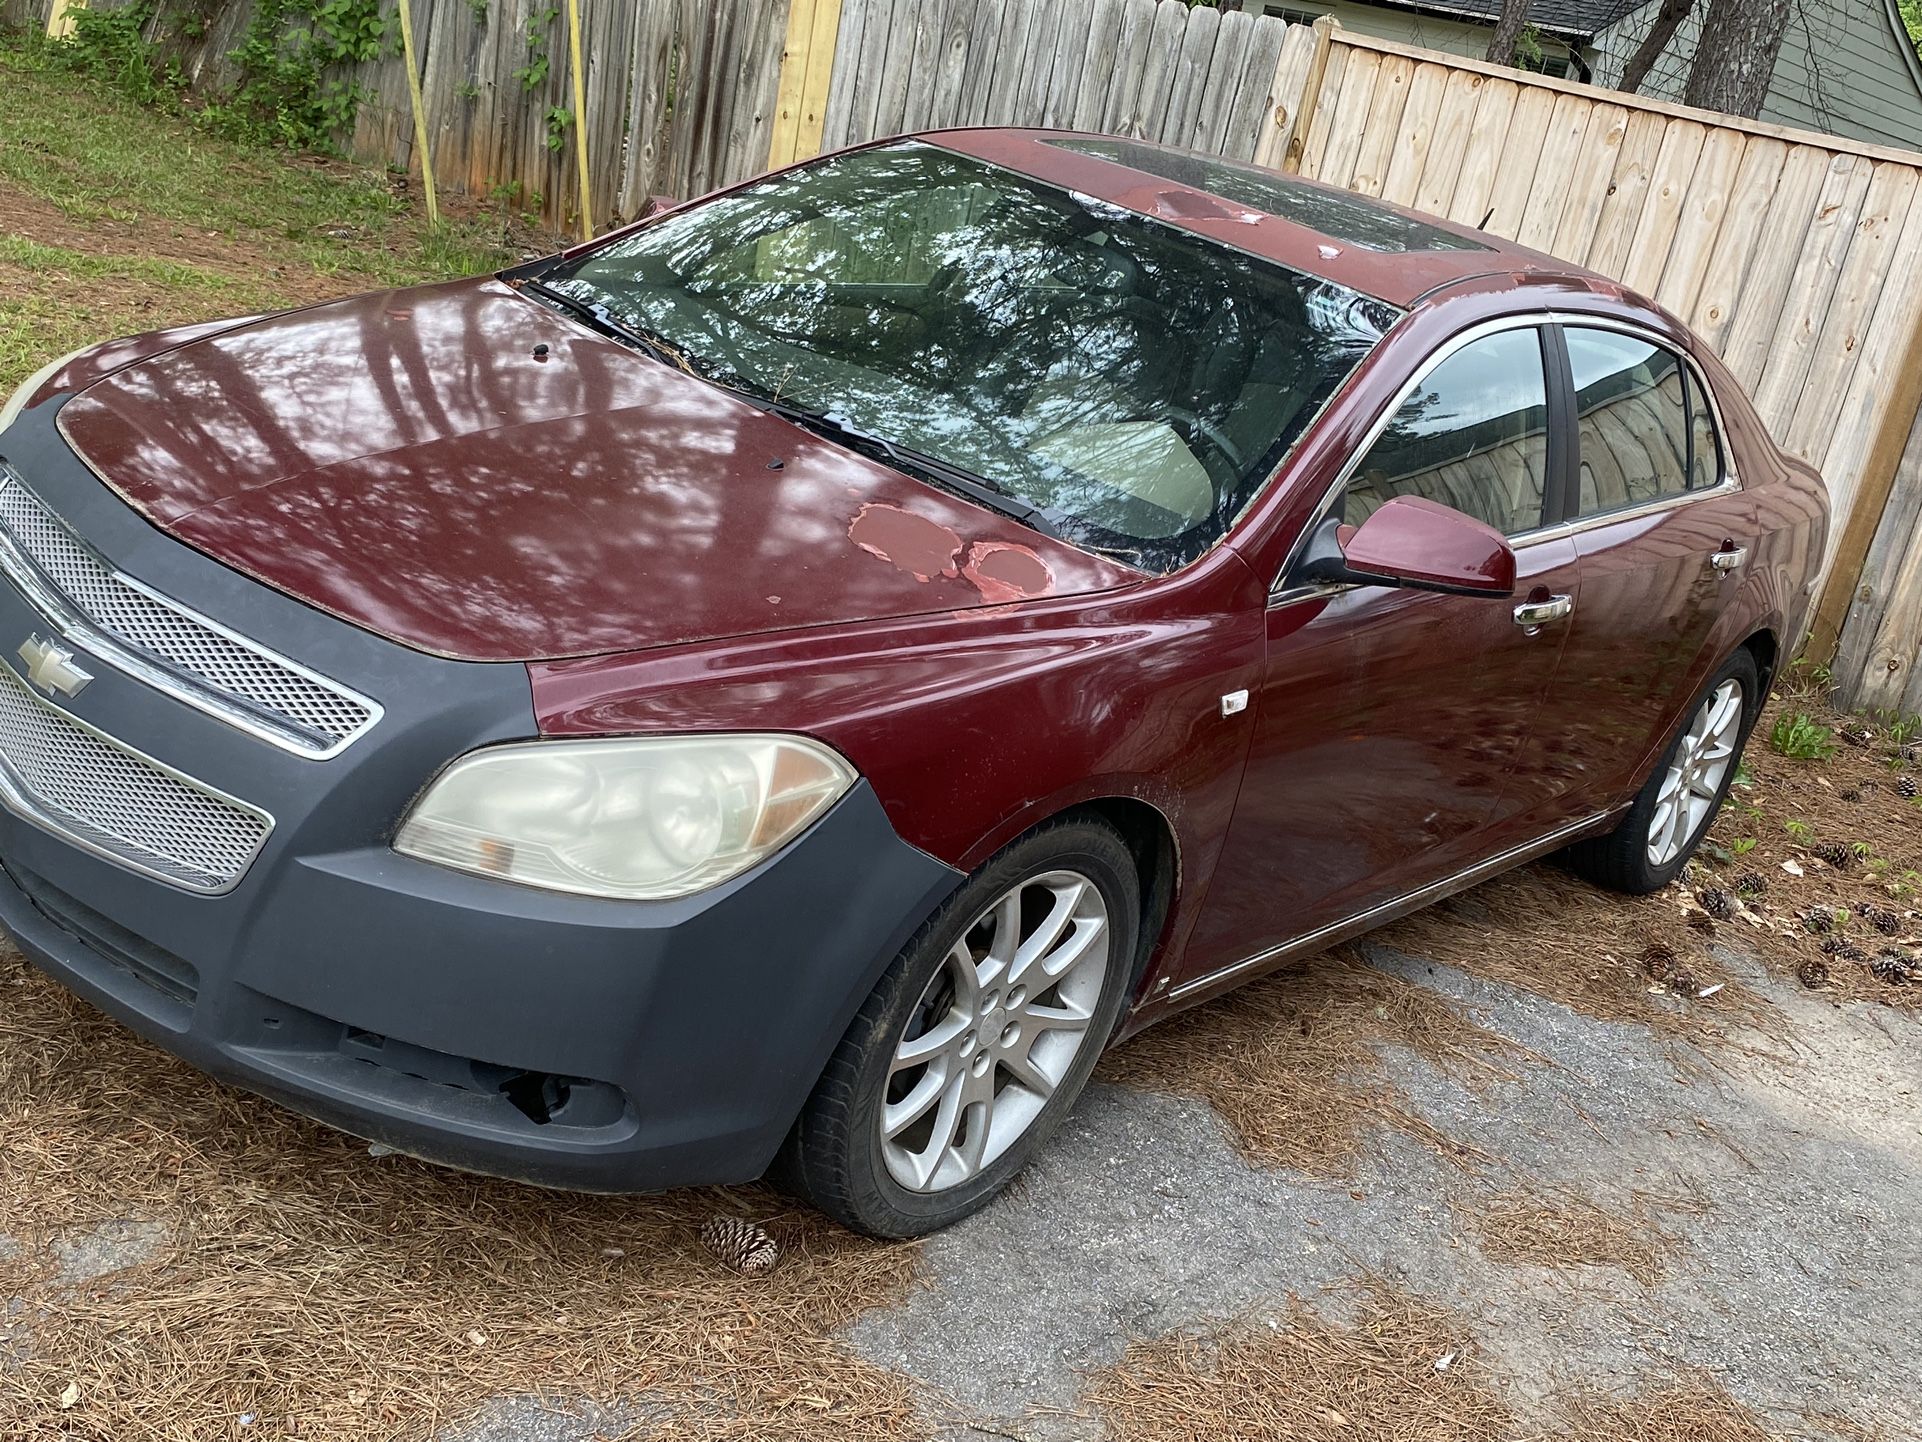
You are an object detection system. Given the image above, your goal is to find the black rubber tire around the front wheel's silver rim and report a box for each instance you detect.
[771,815,1142,1238]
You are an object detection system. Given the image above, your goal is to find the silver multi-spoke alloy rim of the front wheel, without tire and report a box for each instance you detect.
[878,871,1113,1192]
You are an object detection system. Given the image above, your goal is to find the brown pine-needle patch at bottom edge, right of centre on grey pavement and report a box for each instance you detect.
[1088,1284,1509,1442]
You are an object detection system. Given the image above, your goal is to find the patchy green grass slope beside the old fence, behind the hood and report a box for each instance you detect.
[0,44,534,394]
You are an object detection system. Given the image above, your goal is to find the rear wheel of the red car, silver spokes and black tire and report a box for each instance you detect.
[1568,648,1762,896]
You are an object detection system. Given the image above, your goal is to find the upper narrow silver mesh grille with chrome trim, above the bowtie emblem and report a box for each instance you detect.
[0,480,379,756]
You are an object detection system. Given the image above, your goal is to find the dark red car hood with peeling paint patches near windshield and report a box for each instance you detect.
[60,281,1142,661]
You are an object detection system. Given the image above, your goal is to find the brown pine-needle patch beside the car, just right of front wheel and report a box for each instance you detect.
[1101,948,1528,1175]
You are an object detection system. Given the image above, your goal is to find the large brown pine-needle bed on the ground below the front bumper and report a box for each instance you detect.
[0,948,917,1442]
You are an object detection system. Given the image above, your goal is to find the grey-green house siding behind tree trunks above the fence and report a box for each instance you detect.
[1591,0,1922,150]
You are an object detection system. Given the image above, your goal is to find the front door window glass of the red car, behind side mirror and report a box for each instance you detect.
[1342,327,1549,536]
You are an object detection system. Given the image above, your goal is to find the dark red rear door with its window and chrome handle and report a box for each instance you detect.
[1511,321,1757,823]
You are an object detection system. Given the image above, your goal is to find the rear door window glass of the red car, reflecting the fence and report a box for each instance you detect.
[1563,325,1691,515]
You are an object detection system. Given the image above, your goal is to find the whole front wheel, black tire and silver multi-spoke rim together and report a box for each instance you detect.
[782,819,1140,1236]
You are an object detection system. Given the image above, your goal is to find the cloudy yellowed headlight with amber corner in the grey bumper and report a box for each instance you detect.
[394,736,855,900]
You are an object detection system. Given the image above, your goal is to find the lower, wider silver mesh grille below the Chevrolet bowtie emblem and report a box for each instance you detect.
[0,667,273,892]
